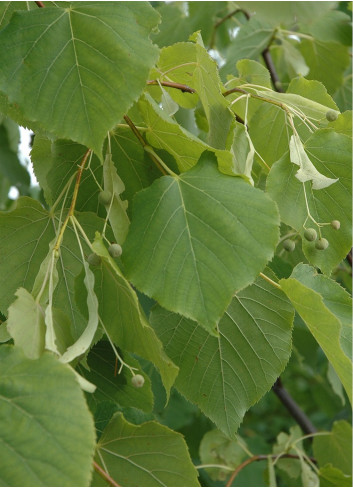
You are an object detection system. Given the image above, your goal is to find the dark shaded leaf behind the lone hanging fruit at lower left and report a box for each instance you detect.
[79,341,153,412]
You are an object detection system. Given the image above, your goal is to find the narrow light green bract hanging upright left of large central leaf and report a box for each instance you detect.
[103,153,130,245]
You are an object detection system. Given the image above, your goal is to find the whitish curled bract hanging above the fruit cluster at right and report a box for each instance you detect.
[289,134,338,190]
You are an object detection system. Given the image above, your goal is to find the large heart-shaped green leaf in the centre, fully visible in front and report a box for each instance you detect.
[122,152,278,333]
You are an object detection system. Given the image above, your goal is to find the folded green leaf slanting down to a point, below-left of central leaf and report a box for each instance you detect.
[93,235,178,397]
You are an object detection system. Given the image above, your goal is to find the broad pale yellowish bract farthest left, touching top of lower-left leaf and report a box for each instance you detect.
[7,287,45,359]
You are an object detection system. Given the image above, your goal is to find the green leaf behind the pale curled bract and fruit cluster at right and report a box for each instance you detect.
[267,129,352,274]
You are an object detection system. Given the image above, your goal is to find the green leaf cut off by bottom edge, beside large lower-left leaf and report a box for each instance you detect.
[96,413,199,487]
